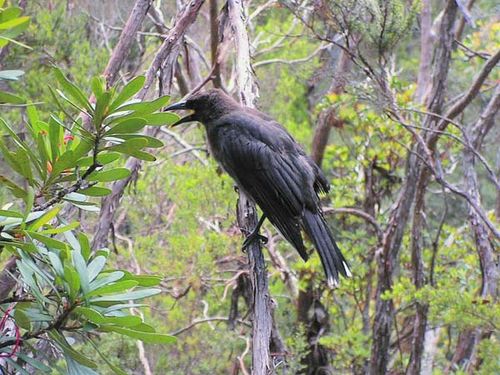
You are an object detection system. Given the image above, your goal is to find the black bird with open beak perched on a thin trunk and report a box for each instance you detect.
[165,89,351,286]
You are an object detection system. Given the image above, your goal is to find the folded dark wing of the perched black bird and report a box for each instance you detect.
[209,115,317,259]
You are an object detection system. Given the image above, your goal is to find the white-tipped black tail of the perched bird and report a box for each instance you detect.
[303,210,351,287]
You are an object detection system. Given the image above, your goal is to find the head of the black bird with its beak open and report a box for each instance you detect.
[165,89,239,126]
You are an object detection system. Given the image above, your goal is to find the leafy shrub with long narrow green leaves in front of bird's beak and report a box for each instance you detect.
[0,69,177,374]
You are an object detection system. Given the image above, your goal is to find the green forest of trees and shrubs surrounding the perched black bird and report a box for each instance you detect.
[0,0,500,374]
